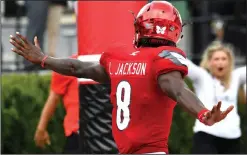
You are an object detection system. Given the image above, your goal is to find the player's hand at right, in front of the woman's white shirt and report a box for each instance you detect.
[203,101,234,126]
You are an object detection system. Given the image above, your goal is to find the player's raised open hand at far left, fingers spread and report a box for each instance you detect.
[9,32,45,64]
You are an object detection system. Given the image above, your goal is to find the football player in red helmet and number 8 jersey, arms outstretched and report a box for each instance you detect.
[10,1,233,154]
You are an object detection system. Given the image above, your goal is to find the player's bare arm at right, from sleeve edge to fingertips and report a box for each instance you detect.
[158,71,233,125]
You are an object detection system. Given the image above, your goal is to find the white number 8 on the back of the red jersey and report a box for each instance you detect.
[116,81,131,130]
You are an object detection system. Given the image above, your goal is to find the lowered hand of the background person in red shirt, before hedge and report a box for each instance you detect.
[34,129,51,149]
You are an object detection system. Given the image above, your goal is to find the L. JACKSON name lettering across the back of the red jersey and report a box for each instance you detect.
[109,62,147,76]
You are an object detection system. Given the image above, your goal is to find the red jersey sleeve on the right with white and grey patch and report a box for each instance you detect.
[153,50,188,79]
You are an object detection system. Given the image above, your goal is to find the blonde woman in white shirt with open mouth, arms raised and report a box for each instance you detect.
[188,41,246,154]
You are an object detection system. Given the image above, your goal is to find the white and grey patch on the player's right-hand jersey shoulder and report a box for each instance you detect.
[159,50,188,66]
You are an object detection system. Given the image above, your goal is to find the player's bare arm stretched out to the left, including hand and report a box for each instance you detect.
[10,32,109,83]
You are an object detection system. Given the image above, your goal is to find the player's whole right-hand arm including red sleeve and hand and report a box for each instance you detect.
[152,47,233,125]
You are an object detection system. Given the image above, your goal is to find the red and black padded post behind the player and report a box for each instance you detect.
[77,1,147,154]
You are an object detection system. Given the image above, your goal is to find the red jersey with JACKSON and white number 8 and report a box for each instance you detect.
[100,46,188,154]
